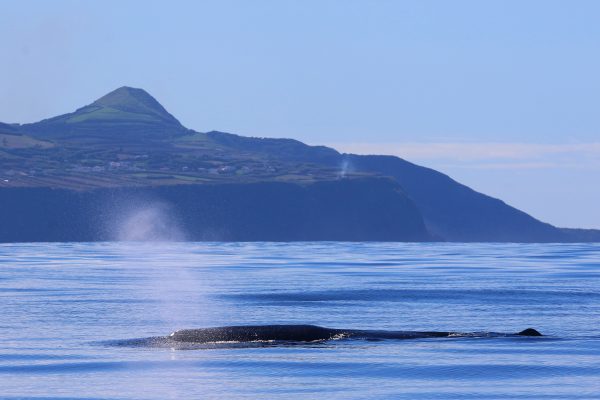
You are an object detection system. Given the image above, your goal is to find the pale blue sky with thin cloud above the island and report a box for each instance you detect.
[0,0,600,228]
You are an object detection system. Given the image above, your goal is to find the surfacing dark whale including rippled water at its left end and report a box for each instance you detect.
[111,325,543,348]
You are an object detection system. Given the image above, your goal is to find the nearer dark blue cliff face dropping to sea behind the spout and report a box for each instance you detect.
[0,178,431,242]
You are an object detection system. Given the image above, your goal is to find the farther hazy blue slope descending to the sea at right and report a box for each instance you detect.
[349,155,568,242]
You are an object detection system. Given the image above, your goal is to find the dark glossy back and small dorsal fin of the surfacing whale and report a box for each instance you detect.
[167,325,542,343]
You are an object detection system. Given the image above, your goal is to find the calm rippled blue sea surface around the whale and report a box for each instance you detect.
[0,243,600,399]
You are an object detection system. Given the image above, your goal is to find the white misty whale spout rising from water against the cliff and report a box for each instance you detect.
[110,196,199,333]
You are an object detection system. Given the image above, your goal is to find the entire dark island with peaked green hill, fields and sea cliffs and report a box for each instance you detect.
[0,87,600,242]
